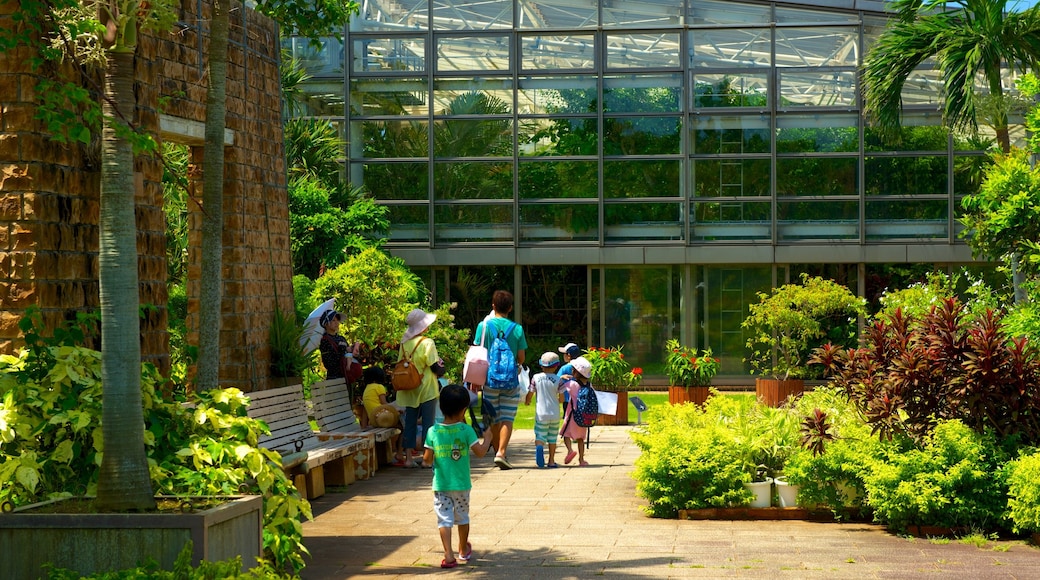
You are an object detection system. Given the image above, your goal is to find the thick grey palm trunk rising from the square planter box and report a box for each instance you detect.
[98,51,155,511]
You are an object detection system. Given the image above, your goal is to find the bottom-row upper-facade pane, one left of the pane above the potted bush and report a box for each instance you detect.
[691,202,773,241]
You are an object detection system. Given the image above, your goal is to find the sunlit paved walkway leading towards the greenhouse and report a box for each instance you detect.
[302,427,1040,580]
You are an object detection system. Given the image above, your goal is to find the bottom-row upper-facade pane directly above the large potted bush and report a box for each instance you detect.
[777,201,859,241]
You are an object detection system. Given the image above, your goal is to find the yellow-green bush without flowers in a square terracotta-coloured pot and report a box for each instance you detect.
[742,274,865,406]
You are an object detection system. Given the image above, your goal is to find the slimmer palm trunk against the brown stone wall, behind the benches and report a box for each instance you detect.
[196,0,231,391]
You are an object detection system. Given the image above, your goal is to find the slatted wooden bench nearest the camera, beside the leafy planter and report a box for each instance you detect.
[248,385,374,499]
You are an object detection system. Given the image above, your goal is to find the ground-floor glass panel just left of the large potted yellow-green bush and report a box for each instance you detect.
[694,265,773,379]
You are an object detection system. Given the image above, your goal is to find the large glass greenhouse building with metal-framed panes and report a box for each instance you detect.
[286,0,998,383]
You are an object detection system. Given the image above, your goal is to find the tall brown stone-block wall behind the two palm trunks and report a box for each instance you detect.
[0,0,292,391]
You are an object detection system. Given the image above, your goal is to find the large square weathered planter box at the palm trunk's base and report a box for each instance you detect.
[0,496,263,578]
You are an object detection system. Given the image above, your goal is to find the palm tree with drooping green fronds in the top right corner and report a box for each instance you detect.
[862,0,1040,152]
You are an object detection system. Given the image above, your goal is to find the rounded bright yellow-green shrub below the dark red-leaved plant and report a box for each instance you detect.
[864,420,1008,530]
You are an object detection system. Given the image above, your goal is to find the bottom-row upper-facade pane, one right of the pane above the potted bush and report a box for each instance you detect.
[866,200,950,240]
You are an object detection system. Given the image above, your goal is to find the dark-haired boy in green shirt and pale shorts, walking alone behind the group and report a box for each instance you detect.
[422,385,491,568]
